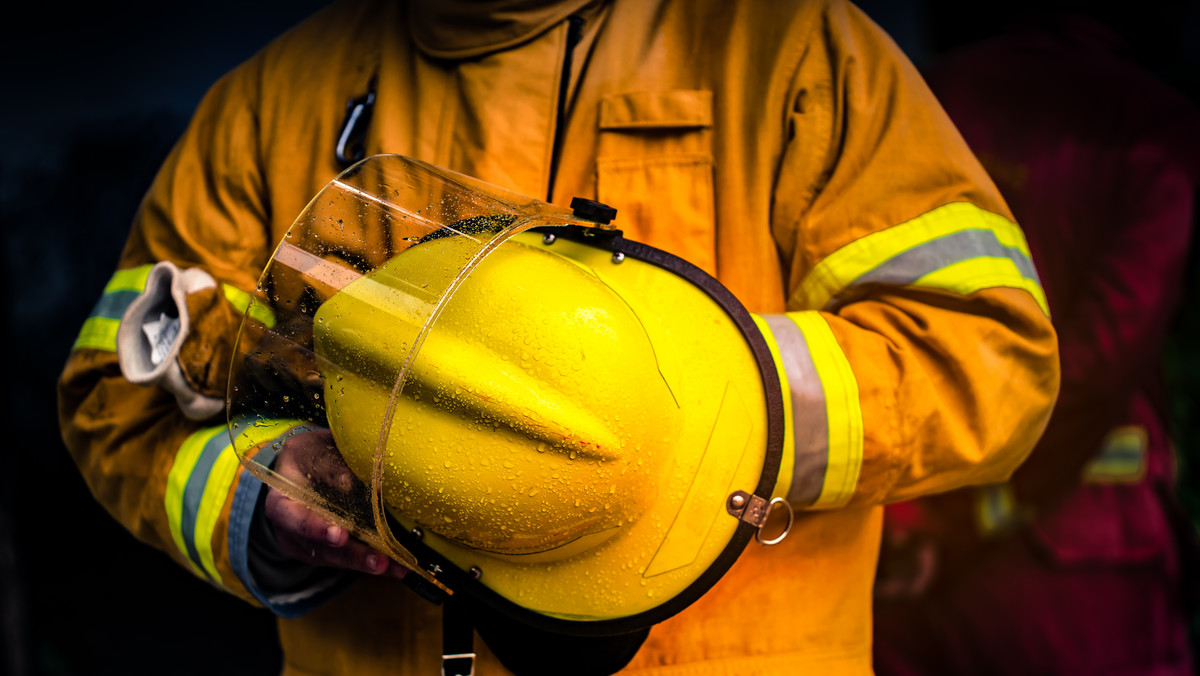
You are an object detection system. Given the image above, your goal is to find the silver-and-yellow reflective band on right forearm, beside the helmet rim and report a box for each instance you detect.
[763,312,863,508]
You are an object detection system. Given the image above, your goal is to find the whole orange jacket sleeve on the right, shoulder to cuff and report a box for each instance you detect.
[764,2,1058,508]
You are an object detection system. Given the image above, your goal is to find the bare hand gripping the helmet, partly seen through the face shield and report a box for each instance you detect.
[265,430,408,578]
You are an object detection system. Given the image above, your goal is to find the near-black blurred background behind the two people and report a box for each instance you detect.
[0,0,1200,676]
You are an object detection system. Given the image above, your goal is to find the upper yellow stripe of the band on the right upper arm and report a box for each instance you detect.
[793,202,1044,310]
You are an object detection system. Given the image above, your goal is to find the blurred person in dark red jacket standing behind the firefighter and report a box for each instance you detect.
[875,9,1200,676]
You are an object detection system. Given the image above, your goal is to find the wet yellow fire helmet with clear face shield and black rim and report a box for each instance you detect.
[229,156,791,635]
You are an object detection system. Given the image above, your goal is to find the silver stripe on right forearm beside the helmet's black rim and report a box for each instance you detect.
[762,315,829,507]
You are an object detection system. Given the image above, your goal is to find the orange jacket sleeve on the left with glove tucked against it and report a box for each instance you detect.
[59,51,343,611]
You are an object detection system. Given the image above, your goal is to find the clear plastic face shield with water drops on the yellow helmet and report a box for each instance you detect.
[228,156,614,586]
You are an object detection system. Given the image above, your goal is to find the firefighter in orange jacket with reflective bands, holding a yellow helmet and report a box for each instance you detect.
[59,0,1058,675]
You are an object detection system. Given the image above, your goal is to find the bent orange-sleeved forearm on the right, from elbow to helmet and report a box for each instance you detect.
[770,288,1058,508]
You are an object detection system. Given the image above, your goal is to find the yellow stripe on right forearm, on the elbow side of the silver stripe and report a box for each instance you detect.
[787,312,863,509]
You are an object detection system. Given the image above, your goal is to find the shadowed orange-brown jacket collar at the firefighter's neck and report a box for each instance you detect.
[408,0,593,59]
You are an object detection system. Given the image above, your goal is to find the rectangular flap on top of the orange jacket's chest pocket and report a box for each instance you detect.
[600,89,713,130]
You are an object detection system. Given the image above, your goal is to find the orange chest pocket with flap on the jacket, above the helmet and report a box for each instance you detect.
[596,90,716,274]
